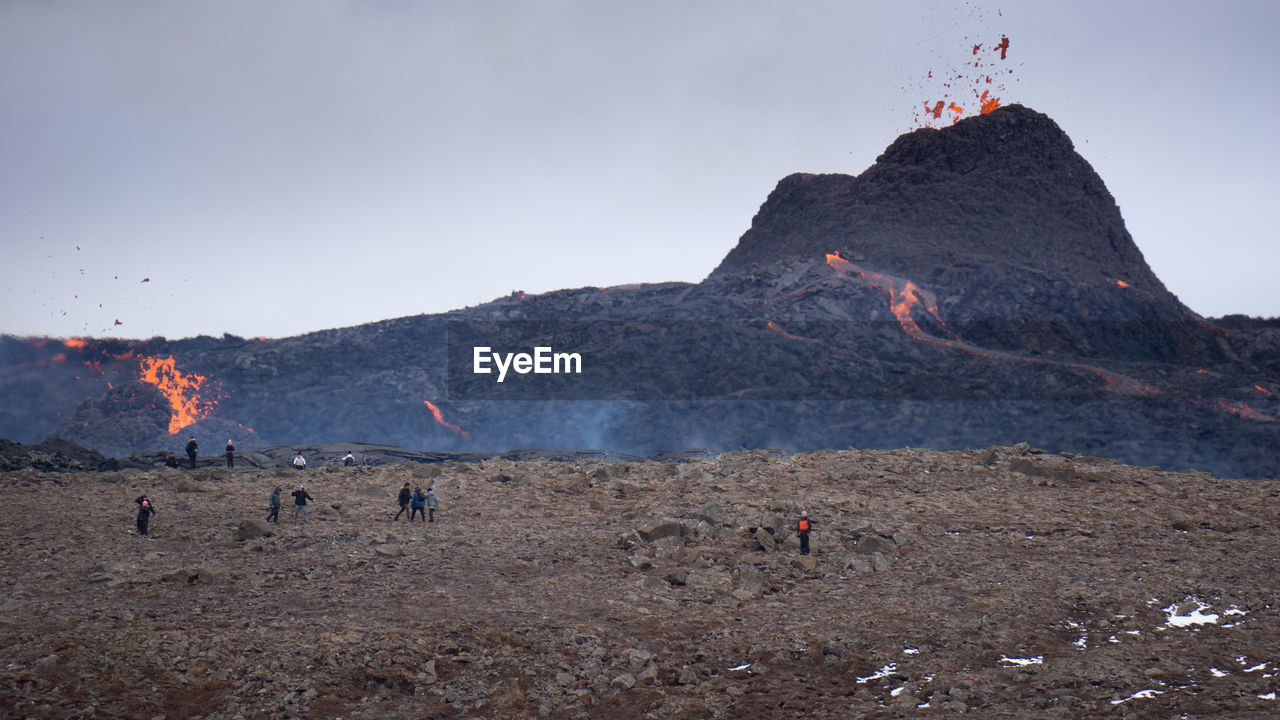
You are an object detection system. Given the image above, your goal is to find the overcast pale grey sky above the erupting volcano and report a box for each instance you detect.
[0,0,1280,337]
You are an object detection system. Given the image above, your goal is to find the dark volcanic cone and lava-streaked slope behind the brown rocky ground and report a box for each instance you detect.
[0,106,1280,477]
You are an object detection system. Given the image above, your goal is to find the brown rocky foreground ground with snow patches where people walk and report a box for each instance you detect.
[0,447,1280,720]
